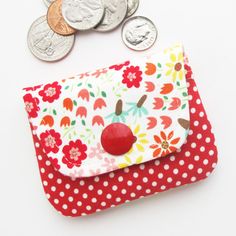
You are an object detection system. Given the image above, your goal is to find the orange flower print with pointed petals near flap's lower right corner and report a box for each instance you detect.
[150,131,180,158]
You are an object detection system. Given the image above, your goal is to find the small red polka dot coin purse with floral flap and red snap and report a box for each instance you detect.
[23,45,217,217]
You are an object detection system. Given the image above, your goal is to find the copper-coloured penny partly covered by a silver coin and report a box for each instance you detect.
[47,0,76,35]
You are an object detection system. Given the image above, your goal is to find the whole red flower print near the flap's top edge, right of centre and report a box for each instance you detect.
[122,66,142,88]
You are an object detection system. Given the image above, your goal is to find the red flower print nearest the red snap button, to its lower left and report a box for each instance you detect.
[62,139,87,169]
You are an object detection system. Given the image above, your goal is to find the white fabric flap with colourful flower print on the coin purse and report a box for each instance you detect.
[24,45,190,178]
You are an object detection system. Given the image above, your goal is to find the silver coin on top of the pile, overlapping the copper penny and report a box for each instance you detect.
[62,0,104,30]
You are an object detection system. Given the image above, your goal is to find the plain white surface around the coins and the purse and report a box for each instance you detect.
[0,0,236,236]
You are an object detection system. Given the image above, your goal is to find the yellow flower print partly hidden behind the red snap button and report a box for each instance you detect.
[118,125,149,168]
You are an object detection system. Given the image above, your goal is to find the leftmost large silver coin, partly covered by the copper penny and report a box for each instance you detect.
[28,16,75,62]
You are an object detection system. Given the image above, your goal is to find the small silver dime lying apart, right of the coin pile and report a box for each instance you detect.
[122,16,158,51]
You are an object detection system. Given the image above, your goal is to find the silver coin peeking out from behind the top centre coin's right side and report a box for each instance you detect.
[95,0,128,32]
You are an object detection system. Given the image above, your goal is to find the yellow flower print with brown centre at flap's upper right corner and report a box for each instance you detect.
[166,52,184,82]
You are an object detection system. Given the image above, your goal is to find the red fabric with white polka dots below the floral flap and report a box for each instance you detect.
[29,73,217,217]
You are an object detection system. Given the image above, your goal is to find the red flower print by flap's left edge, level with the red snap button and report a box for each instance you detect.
[40,129,62,153]
